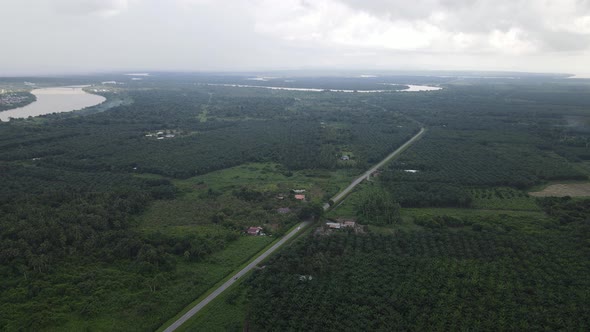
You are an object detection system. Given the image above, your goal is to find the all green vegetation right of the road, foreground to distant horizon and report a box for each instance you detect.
[244,77,590,331]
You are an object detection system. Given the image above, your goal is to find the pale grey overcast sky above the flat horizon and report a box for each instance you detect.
[0,0,590,76]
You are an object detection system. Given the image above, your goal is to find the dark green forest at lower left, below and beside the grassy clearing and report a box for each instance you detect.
[0,163,250,330]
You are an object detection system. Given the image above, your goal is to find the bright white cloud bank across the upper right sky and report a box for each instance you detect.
[255,0,590,55]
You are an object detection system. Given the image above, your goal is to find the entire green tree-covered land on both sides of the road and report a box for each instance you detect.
[0,74,590,331]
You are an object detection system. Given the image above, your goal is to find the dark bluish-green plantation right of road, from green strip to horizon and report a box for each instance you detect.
[370,82,590,209]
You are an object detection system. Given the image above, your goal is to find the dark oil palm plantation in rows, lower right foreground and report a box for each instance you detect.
[247,202,590,331]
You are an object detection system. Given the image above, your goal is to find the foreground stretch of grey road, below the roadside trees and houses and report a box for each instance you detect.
[164,221,310,332]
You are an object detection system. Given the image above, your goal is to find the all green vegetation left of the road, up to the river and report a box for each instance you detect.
[0,77,417,330]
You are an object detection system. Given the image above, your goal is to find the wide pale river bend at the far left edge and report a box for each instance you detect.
[0,86,106,121]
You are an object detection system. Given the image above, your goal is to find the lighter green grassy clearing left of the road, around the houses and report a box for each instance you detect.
[137,163,355,236]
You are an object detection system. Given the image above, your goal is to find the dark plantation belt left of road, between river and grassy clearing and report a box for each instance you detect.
[0,89,416,178]
